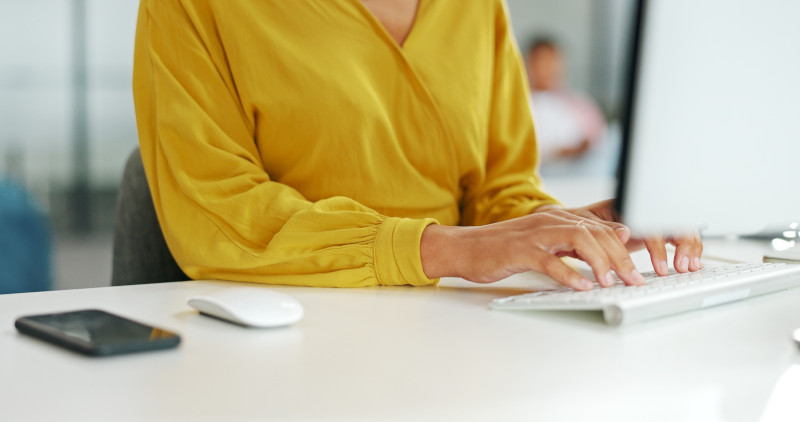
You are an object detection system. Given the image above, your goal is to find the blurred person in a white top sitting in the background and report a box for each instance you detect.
[526,38,606,164]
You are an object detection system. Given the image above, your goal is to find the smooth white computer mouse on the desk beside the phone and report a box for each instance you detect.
[186,287,303,327]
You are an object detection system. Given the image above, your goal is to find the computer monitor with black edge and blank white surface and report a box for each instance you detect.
[617,0,800,234]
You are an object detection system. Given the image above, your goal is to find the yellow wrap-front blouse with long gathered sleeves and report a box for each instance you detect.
[133,0,554,287]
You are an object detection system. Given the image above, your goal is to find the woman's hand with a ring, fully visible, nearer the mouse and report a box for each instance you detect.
[420,208,644,290]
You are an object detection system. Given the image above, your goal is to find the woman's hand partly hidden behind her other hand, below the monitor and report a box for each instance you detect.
[537,200,703,276]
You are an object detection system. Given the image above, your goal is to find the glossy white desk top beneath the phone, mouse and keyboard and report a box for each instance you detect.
[0,239,800,422]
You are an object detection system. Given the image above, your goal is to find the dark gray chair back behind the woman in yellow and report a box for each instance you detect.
[111,148,189,286]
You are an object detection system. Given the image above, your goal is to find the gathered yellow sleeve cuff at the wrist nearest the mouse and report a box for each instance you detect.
[374,217,439,286]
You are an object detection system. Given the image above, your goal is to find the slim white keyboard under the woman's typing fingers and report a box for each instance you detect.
[489,263,800,325]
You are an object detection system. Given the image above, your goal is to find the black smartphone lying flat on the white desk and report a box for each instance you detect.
[14,309,181,356]
